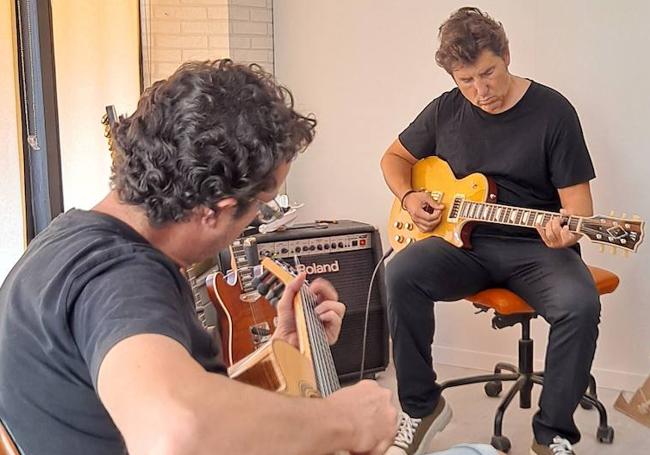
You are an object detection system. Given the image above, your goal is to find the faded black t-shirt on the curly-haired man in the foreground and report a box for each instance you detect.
[0,210,225,455]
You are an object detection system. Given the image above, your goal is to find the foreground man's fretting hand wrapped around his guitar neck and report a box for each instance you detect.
[273,273,345,348]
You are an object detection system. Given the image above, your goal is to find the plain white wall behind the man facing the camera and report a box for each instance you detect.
[274,0,650,390]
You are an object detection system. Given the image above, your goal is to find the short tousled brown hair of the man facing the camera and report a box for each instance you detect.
[436,6,508,74]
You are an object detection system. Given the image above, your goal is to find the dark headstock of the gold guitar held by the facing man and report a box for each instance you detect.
[579,215,645,252]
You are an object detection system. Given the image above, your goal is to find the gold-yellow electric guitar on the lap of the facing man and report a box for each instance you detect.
[388,156,644,252]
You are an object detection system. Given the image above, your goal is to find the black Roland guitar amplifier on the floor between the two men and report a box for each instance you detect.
[254,220,388,381]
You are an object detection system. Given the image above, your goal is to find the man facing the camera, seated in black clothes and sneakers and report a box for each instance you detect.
[381,8,600,455]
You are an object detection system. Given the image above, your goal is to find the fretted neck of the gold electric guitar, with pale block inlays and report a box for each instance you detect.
[449,200,583,233]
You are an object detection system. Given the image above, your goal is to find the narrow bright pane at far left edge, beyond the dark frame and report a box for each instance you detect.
[0,0,25,283]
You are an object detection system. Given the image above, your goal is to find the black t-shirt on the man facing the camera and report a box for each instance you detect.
[399,81,595,238]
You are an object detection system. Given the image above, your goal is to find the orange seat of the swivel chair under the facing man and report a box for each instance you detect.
[465,266,619,315]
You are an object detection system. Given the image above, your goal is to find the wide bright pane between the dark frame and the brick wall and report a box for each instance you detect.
[52,0,140,210]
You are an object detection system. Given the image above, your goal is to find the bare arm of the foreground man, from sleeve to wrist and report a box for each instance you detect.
[98,335,358,455]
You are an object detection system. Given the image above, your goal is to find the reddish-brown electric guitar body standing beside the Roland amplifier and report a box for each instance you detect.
[206,272,276,366]
